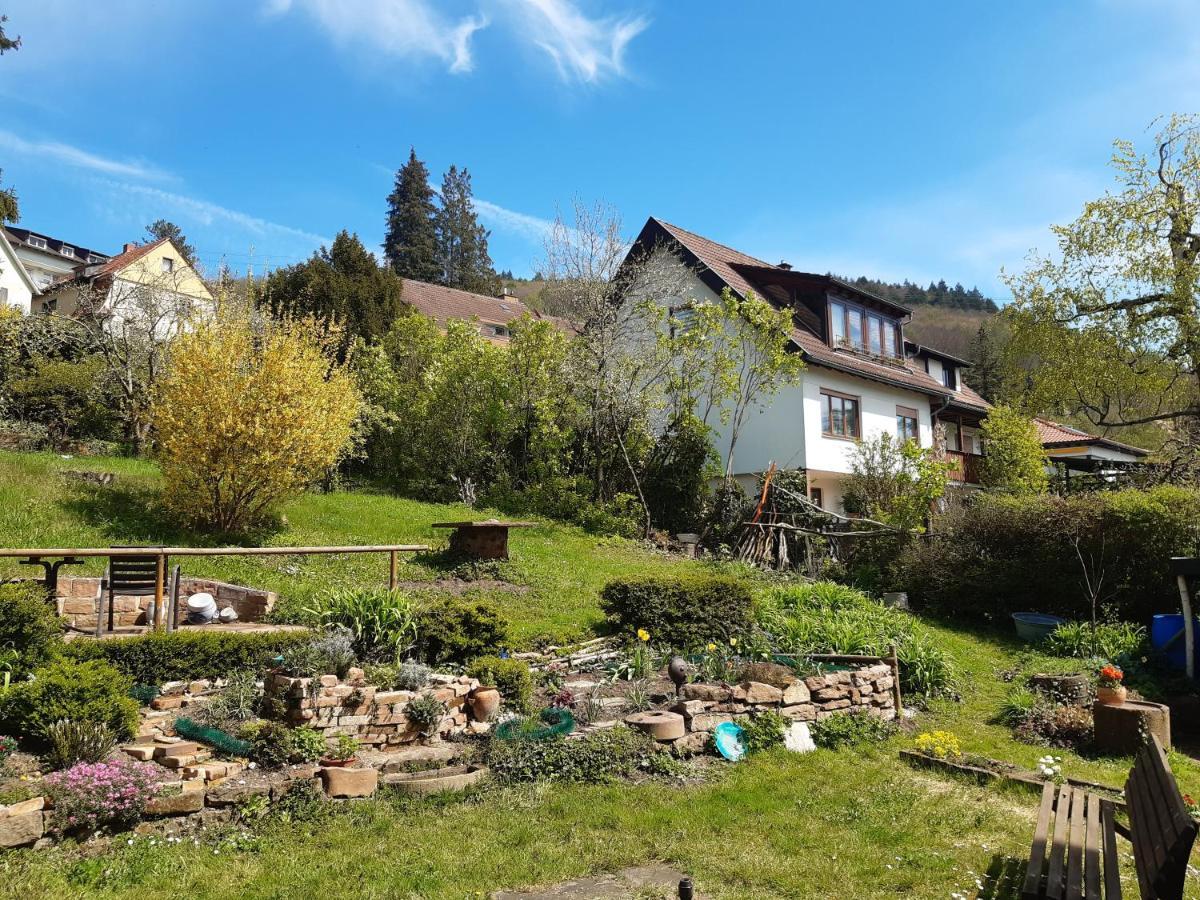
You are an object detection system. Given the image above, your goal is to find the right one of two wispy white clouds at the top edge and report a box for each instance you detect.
[510,0,649,82]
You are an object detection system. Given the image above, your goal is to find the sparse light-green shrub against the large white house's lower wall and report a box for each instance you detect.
[842,432,952,532]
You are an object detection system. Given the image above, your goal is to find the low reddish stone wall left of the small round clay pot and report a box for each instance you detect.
[265,668,490,748]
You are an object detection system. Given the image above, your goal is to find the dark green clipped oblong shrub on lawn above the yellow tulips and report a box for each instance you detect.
[600,575,752,650]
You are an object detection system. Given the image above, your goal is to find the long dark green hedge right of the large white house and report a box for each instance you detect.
[895,486,1200,624]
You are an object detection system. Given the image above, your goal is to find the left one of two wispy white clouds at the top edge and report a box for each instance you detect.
[265,0,487,72]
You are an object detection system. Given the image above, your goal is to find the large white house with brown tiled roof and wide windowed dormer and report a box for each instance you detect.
[630,217,990,511]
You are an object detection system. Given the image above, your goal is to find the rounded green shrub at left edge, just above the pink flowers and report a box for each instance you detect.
[0,657,138,744]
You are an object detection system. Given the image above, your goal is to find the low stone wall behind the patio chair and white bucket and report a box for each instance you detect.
[56,575,276,631]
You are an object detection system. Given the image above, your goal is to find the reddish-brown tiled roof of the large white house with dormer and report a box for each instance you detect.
[653,218,991,413]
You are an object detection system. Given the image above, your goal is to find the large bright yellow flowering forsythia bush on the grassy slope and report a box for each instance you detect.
[152,313,359,532]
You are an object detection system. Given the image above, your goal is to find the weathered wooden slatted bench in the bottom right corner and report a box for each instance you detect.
[1021,738,1196,900]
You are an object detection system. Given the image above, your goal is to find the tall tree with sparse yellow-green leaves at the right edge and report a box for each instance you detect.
[1007,115,1200,458]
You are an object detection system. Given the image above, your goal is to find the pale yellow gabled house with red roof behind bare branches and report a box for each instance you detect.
[36,238,216,328]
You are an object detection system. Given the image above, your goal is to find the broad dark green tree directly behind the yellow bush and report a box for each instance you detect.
[259,232,406,356]
